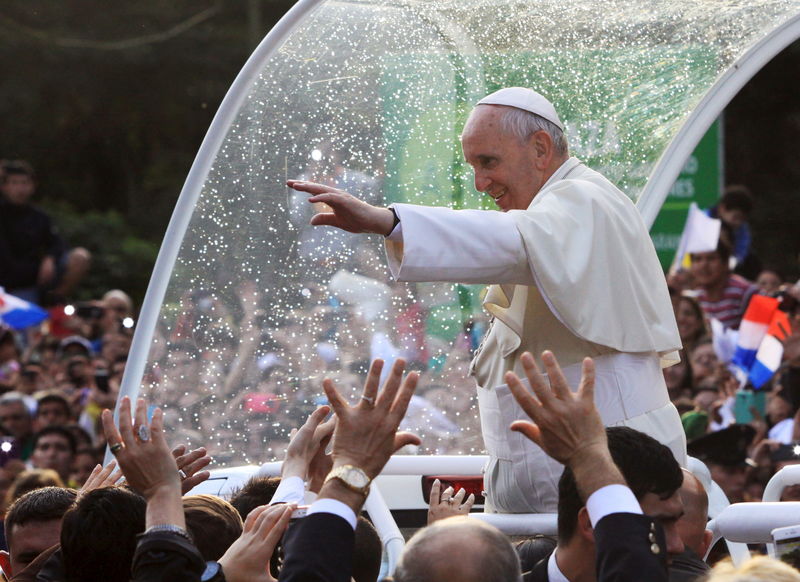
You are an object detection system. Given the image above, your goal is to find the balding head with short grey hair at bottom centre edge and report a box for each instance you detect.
[394,517,521,582]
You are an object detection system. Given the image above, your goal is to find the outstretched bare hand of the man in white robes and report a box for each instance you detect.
[286,180,394,236]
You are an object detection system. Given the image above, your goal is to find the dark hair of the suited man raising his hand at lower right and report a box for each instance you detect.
[558,426,683,541]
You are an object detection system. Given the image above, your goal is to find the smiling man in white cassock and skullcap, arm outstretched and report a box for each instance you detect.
[289,87,686,513]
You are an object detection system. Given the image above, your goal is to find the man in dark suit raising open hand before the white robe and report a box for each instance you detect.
[506,352,683,582]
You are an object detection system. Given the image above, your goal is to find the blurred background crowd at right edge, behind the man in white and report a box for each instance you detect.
[664,186,800,502]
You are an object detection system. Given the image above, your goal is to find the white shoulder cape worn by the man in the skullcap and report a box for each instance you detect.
[484,158,681,366]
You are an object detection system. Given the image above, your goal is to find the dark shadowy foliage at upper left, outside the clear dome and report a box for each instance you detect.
[0,0,294,302]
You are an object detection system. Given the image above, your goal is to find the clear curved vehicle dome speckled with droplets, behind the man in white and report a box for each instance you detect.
[122,0,800,466]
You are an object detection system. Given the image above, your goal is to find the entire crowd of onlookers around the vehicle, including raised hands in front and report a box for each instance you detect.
[0,107,800,582]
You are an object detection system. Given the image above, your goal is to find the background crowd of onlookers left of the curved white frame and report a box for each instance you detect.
[0,161,135,510]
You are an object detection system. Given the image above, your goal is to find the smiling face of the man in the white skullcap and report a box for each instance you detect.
[461,105,546,212]
